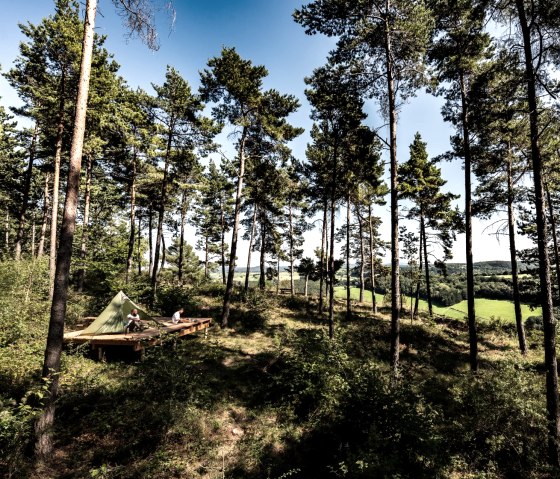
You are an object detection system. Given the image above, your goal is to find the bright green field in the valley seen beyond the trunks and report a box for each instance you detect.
[335,286,542,322]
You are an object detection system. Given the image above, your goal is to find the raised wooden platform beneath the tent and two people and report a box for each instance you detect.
[64,318,212,358]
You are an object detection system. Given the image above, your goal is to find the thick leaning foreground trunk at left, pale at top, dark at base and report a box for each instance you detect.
[35,0,97,460]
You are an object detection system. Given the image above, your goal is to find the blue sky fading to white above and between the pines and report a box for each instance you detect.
[0,0,528,264]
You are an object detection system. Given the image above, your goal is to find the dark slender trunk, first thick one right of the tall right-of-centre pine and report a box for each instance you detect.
[460,73,478,371]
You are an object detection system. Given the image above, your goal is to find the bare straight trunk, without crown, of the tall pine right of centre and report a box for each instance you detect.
[385,20,401,378]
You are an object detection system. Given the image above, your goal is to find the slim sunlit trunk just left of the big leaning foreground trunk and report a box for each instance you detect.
[49,71,67,301]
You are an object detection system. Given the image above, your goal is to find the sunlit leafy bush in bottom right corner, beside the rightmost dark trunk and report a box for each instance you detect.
[446,364,547,477]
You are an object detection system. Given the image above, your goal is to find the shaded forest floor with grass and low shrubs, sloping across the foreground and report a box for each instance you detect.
[0,286,553,479]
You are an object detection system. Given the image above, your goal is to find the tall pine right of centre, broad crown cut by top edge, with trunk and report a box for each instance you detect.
[294,0,432,377]
